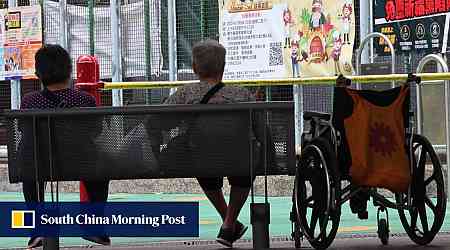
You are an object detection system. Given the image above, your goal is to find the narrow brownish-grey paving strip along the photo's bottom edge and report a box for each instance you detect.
[61,235,450,250]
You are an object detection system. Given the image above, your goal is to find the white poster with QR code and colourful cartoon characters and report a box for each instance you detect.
[219,0,355,79]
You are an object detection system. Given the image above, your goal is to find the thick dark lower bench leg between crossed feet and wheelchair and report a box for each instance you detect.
[250,203,270,249]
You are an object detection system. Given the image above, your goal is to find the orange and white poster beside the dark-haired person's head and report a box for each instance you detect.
[0,6,42,80]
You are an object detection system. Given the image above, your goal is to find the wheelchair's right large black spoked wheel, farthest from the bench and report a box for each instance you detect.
[396,135,447,245]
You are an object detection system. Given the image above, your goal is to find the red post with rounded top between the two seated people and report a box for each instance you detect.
[75,55,102,202]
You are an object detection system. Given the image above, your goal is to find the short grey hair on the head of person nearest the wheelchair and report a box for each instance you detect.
[192,39,226,78]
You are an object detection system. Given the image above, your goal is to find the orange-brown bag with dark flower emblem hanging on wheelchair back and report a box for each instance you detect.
[344,86,411,192]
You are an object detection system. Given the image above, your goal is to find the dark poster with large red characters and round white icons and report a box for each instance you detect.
[373,0,450,55]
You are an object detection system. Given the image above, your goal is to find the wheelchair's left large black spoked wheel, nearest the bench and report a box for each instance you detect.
[294,138,341,249]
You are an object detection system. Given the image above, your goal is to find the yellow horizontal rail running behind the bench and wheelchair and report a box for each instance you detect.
[103,73,450,90]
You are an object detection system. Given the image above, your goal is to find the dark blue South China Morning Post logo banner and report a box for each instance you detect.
[0,202,199,237]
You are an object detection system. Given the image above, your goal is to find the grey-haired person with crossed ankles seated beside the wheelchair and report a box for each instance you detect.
[165,40,256,247]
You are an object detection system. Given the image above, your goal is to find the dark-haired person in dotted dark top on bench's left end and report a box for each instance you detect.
[20,45,110,248]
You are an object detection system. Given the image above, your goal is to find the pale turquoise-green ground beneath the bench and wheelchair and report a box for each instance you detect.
[0,192,450,250]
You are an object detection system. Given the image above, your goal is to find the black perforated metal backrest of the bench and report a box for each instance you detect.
[6,103,295,183]
